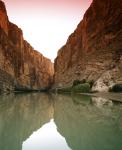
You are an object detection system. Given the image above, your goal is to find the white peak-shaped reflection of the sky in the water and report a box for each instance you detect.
[22,119,71,150]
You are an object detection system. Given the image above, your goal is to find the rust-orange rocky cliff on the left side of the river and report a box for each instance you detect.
[0,1,54,91]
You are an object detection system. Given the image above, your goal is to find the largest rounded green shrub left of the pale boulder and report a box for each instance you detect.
[72,83,91,93]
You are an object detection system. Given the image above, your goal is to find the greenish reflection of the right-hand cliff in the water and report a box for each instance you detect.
[54,95,122,150]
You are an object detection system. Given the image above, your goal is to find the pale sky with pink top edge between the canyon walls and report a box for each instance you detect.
[3,0,92,62]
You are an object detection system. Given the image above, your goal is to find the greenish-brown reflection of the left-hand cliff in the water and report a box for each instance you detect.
[0,94,53,150]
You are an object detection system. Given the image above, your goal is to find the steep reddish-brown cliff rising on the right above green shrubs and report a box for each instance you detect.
[54,0,122,91]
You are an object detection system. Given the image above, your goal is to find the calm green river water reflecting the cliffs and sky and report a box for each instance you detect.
[0,93,122,150]
